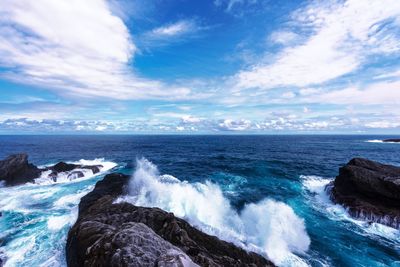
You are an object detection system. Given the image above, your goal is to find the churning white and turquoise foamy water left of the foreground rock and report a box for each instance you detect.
[0,159,117,267]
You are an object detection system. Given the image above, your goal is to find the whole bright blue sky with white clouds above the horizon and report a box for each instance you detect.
[0,0,400,134]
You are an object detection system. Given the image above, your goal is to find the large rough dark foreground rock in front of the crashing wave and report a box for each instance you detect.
[66,174,273,267]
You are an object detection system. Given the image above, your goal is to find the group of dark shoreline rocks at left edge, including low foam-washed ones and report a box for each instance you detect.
[0,153,103,186]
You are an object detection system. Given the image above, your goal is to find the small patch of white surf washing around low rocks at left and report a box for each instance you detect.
[34,158,117,185]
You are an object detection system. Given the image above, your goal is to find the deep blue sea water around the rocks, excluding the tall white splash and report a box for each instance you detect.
[0,135,400,266]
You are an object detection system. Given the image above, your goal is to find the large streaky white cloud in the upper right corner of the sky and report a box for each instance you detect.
[233,0,400,89]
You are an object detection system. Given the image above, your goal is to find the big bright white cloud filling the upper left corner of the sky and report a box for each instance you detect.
[0,0,190,99]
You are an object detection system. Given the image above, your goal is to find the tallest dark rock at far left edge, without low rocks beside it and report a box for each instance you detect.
[0,154,41,186]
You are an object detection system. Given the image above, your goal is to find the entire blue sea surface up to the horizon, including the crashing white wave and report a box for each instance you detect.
[0,135,400,267]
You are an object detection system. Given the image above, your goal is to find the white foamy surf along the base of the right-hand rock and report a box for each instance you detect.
[300,175,400,240]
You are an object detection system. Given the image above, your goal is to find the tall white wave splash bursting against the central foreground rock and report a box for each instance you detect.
[116,159,310,266]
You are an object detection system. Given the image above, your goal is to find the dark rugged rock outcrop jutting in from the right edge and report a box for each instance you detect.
[327,158,400,229]
